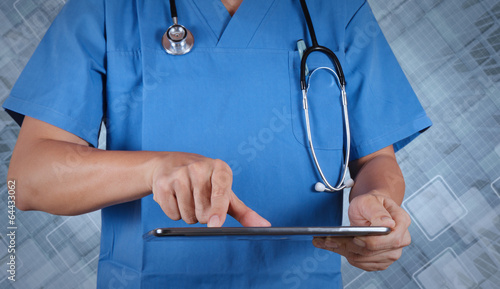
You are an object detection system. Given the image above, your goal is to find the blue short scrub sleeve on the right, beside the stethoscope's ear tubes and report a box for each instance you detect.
[344,1,432,160]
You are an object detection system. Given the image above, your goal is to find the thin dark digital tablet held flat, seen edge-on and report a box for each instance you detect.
[144,226,391,240]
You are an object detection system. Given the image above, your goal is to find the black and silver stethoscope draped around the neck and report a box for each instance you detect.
[162,0,354,192]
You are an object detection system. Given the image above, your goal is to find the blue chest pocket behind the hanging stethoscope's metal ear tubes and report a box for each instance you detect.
[289,51,345,150]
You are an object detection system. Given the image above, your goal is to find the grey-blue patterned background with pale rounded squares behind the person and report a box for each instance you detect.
[0,0,500,289]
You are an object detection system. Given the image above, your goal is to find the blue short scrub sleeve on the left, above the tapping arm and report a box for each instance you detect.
[3,0,106,147]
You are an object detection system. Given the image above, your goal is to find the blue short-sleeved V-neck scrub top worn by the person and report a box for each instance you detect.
[4,0,431,288]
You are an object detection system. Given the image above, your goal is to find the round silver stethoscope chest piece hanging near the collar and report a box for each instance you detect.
[161,24,194,55]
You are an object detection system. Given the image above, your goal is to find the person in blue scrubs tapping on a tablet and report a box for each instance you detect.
[4,0,431,288]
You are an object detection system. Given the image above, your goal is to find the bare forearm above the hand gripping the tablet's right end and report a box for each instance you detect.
[349,146,405,205]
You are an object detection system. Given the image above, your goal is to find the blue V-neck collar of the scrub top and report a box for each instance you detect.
[192,0,275,48]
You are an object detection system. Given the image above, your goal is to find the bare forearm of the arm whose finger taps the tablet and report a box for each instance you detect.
[8,140,159,215]
